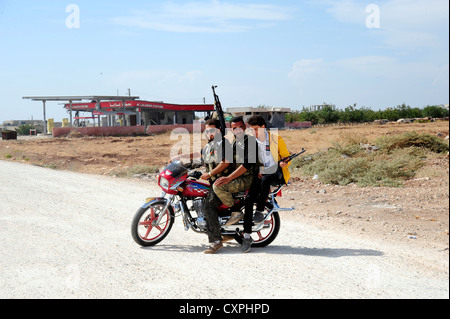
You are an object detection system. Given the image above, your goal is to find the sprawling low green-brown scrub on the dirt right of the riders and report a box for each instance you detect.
[293,132,449,187]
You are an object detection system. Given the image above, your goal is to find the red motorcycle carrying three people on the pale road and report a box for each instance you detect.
[131,161,295,247]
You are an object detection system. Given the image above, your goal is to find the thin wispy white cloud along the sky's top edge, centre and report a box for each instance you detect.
[111,0,292,33]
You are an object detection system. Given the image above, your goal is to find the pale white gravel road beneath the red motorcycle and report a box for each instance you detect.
[0,161,449,299]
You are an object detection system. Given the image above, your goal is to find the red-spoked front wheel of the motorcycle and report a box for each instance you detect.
[131,201,175,247]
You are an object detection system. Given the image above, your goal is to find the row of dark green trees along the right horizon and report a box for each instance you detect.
[286,103,449,124]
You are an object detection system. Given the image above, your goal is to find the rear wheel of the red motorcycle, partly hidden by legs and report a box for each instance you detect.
[234,203,281,248]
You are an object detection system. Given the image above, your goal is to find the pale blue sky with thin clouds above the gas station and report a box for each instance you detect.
[0,0,449,122]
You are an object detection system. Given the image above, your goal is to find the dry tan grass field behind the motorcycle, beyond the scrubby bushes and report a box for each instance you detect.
[0,122,449,185]
